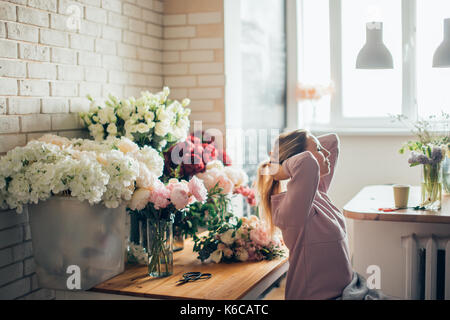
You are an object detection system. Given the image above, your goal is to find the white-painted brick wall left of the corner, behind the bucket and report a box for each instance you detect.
[0,0,163,299]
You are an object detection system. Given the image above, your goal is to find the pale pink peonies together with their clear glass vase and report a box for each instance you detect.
[129,177,207,277]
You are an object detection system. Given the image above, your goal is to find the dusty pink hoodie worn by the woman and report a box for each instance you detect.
[271,134,353,299]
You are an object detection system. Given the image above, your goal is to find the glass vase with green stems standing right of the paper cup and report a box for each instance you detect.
[421,163,442,210]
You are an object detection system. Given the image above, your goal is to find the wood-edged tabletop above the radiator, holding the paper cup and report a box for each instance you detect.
[343,185,450,223]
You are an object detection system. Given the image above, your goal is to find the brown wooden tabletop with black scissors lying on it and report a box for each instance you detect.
[91,235,288,300]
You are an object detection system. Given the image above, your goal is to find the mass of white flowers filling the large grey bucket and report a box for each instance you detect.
[0,135,164,213]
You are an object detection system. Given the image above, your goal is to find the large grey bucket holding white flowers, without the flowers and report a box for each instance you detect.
[28,196,127,290]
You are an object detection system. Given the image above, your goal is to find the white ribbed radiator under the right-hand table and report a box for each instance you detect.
[402,234,450,300]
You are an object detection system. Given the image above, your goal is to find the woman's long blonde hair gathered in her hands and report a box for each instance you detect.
[255,129,309,234]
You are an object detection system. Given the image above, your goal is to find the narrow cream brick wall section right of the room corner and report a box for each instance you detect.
[163,0,225,140]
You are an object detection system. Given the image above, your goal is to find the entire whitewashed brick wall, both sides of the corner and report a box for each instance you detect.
[0,0,225,299]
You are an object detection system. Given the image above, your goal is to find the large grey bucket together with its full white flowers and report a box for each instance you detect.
[0,135,163,290]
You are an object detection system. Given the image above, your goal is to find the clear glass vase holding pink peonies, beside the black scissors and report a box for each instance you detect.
[147,219,173,278]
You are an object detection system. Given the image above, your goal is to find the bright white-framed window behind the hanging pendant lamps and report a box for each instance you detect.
[297,0,450,130]
